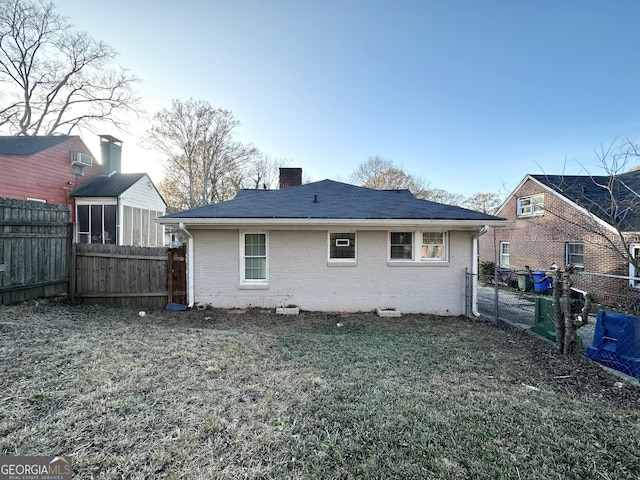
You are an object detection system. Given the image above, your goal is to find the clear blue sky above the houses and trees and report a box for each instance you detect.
[53,0,640,196]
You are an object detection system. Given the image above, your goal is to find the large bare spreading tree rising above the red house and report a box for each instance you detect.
[0,0,139,135]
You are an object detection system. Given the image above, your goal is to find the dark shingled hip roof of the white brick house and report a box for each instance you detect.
[162,180,500,220]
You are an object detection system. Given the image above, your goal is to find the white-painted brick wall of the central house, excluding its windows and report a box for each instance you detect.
[191,229,473,315]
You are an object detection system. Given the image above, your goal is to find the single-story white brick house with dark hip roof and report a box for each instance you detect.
[159,176,504,315]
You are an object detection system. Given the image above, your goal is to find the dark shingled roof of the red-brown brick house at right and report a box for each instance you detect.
[531,170,640,232]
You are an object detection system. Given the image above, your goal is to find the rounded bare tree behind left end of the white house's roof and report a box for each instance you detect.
[145,99,259,211]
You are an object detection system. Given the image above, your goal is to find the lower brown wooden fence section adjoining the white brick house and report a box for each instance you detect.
[74,244,186,308]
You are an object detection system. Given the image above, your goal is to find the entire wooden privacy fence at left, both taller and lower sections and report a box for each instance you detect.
[0,198,187,308]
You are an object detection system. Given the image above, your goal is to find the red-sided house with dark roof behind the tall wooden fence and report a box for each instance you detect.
[0,135,100,210]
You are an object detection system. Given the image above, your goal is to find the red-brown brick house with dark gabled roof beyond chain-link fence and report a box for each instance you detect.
[479,171,640,302]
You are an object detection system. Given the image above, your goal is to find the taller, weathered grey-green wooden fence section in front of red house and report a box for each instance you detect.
[0,198,73,305]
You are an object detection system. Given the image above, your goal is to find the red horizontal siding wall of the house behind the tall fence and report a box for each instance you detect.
[0,137,100,205]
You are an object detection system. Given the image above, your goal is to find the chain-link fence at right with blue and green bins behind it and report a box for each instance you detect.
[467,269,640,378]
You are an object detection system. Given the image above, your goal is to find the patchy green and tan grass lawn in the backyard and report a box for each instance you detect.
[0,302,640,480]
